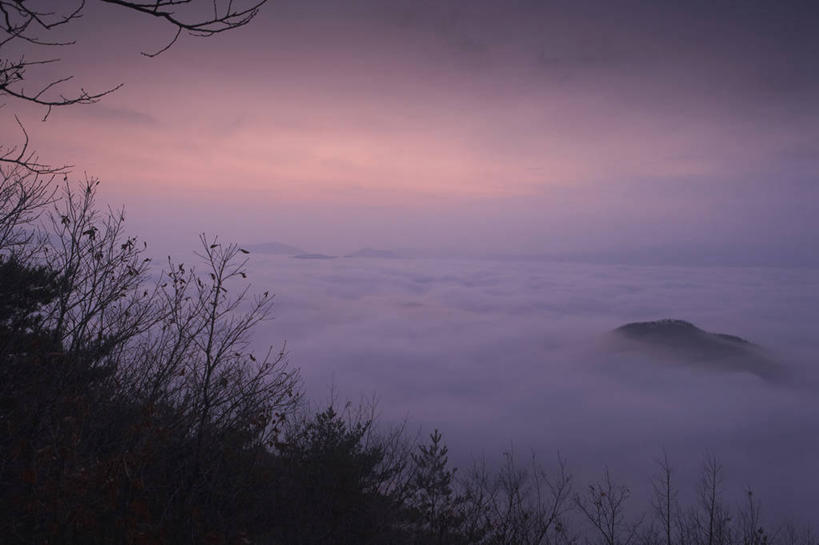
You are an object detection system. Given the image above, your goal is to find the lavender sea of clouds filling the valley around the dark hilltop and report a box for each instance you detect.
[243,254,819,520]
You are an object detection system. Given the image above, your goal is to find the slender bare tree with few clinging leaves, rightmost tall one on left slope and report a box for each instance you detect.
[178,235,298,450]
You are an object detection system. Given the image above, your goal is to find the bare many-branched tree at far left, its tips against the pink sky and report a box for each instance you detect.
[43,179,159,364]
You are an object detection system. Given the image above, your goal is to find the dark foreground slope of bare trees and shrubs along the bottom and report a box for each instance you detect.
[0,176,817,545]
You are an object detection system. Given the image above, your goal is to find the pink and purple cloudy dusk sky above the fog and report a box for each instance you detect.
[2,0,819,266]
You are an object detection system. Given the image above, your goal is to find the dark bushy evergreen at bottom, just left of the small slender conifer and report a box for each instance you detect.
[269,406,403,545]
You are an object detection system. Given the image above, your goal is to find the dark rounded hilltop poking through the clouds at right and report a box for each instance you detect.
[612,319,785,381]
